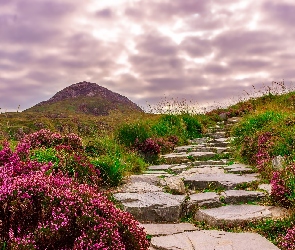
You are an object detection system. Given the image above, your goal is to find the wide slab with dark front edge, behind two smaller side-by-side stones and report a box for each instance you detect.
[184,173,257,190]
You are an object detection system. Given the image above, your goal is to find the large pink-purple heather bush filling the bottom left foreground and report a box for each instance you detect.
[0,142,149,250]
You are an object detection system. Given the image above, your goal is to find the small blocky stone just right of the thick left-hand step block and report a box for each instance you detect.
[187,192,222,212]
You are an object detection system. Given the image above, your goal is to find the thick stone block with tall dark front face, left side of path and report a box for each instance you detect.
[114,192,185,222]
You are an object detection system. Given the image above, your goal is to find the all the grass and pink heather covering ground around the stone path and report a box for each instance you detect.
[0,82,295,250]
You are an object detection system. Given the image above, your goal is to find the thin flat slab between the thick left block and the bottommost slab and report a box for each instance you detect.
[140,223,197,236]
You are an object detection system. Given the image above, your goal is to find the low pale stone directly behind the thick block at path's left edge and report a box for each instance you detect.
[118,181,162,193]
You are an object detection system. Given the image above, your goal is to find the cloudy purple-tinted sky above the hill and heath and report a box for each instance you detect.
[0,0,295,111]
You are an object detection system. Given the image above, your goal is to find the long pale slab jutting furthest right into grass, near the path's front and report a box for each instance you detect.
[195,205,286,226]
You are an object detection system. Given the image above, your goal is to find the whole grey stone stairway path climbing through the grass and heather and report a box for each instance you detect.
[114,118,287,250]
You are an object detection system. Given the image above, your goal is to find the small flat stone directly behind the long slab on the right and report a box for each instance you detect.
[221,190,265,204]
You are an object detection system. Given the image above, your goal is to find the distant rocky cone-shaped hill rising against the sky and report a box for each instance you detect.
[25,81,143,116]
